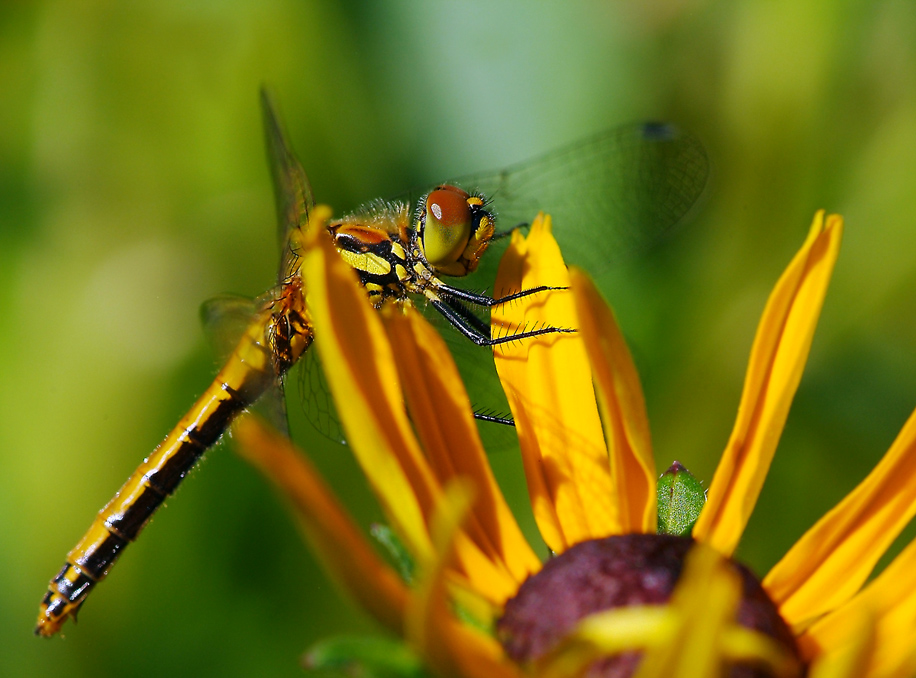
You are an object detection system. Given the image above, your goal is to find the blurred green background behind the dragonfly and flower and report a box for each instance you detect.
[0,0,916,678]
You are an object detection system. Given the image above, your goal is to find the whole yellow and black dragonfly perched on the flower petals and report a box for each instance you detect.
[35,90,708,637]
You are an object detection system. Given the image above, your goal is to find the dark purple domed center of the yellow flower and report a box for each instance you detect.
[496,534,799,678]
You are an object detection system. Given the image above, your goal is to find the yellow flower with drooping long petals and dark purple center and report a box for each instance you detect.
[236,208,916,678]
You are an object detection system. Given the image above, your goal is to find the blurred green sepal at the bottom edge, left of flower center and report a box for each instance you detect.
[302,636,429,678]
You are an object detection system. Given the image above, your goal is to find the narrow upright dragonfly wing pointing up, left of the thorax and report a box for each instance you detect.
[261,88,315,282]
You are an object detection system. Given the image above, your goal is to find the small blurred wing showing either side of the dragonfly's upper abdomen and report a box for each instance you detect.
[200,294,289,433]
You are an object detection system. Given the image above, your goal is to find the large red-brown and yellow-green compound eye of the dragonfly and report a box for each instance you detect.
[422,186,473,267]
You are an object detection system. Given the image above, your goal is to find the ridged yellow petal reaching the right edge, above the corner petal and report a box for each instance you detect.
[763,404,916,626]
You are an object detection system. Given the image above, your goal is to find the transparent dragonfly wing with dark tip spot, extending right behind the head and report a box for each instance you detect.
[454,123,709,271]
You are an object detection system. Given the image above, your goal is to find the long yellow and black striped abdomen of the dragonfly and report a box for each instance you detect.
[35,283,312,636]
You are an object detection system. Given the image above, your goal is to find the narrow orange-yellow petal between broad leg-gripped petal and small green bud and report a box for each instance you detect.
[569,268,657,533]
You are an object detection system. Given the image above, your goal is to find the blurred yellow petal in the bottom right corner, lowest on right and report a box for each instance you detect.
[800,541,916,677]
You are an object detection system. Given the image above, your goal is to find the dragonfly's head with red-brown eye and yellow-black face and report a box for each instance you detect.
[417,184,495,276]
